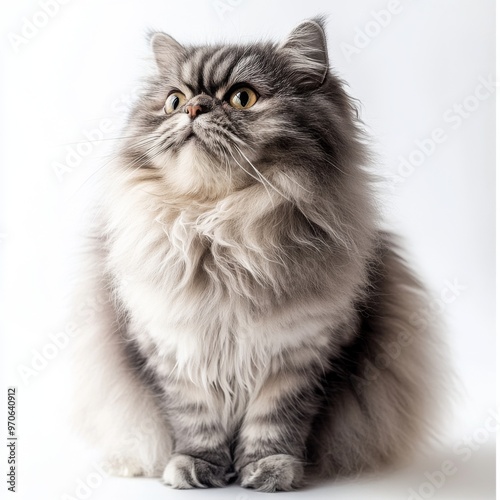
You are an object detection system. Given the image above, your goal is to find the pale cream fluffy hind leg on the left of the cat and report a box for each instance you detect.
[70,250,171,476]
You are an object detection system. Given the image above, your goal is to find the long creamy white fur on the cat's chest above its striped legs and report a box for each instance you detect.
[108,173,346,398]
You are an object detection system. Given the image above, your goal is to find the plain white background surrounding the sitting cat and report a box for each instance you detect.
[0,0,495,500]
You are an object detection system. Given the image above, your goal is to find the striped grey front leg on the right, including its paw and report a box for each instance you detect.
[235,353,321,492]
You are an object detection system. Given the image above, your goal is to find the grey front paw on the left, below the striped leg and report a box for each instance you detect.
[162,455,233,490]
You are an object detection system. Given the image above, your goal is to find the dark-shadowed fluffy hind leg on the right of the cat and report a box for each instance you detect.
[308,240,451,477]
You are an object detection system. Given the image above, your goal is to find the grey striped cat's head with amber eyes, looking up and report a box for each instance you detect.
[126,19,361,201]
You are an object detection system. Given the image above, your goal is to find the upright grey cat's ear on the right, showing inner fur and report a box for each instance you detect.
[279,19,328,88]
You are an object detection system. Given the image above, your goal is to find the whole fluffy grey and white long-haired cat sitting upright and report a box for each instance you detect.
[71,19,441,491]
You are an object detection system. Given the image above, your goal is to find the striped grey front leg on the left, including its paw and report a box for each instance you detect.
[163,379,234,489]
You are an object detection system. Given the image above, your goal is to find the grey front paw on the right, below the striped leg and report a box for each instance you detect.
[240,455,304,492]
